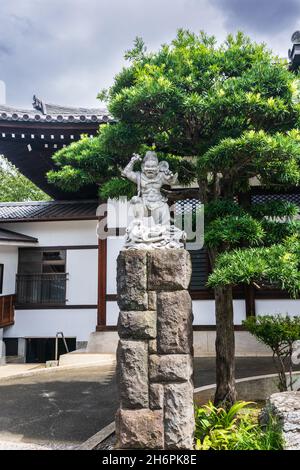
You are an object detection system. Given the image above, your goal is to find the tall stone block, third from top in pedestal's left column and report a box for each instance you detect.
[117,340,149,409]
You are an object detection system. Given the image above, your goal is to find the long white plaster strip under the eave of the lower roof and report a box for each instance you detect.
[1,220,98,246]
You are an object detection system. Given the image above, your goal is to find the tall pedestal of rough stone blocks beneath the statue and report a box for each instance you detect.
[116,249,194,449]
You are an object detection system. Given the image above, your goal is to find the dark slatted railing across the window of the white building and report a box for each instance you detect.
[16,273,67,305]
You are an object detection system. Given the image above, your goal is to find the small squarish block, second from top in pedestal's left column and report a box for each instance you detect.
[118,310,156,339]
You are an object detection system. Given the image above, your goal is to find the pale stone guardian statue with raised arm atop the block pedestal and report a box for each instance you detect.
[122,151,185,249]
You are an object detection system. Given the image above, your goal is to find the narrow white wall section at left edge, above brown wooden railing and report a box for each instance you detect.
[0,246,18,295]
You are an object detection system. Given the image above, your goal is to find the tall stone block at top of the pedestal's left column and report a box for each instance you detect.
[117,250,148,311]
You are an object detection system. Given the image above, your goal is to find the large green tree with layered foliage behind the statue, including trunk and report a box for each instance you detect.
[49,30,300,404]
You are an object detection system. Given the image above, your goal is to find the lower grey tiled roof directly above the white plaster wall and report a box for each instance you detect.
[0,200,99,222]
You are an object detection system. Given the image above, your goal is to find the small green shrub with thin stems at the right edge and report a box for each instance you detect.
[243,315,300,392]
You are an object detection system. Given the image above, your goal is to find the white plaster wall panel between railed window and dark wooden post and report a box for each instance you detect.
[66,249,98,305]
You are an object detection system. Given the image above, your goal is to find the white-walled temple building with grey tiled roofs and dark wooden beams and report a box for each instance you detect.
[0,97,300,362]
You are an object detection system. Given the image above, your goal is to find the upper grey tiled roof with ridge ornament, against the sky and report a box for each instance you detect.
[0,96,113,124]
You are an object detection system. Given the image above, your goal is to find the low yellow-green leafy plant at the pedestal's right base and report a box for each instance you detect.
[195,401,283,450]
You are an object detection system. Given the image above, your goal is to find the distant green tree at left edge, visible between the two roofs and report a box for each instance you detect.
[0,157,50,202]
